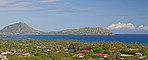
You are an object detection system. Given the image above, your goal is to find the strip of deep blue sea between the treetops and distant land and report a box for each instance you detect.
[0,34,148,44]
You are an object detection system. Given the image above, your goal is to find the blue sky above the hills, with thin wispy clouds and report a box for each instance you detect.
[0,0,148,32]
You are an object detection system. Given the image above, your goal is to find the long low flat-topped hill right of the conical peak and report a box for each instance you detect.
[49,27,114,35]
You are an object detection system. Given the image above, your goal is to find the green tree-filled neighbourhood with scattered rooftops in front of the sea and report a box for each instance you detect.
[0,39,148,60]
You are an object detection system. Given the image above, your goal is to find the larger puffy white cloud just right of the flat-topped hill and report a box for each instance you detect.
[107,22,135,30]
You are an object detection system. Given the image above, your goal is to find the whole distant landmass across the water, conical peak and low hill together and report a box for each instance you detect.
[0,22,114,35]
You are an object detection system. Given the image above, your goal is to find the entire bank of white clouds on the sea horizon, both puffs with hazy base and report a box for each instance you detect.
[107,22,148,34]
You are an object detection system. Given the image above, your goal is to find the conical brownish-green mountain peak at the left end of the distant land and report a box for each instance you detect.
[0,22,39,34]
